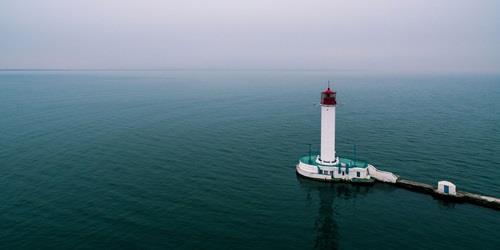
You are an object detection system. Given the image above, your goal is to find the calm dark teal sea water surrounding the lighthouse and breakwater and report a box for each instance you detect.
[0,71,500,249]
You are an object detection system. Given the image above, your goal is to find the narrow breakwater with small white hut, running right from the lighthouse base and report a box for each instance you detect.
[369,167,500,210]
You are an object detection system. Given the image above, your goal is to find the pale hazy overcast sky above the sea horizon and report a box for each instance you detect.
[0,0,500,72]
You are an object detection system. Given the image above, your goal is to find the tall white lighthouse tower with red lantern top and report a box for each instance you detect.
[318,87,338,165]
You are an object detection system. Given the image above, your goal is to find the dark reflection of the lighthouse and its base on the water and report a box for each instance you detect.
[297,175,371,249]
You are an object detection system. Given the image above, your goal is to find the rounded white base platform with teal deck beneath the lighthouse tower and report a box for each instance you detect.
[296,156,375,183]
